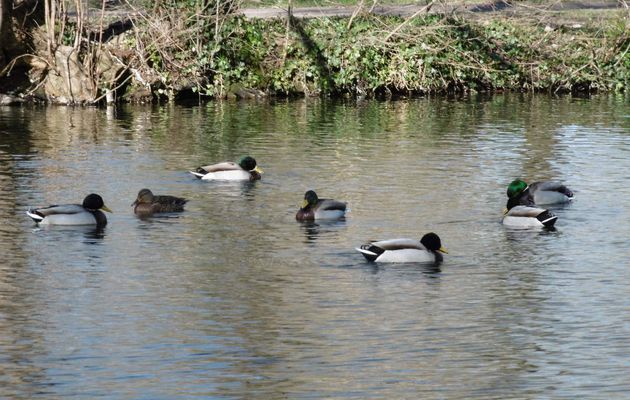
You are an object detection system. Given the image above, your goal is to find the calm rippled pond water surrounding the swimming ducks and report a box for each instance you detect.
[0,95,630,399]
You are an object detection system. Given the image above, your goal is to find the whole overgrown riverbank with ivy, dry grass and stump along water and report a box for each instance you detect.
[0,1,630,103]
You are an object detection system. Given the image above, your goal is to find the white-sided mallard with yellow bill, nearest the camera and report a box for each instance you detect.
[357,232,448,263]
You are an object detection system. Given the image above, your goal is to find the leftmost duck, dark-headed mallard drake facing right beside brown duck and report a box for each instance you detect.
[26,193,112,226]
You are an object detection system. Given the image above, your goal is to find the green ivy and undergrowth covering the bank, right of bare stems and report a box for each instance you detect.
[205,16,630,96]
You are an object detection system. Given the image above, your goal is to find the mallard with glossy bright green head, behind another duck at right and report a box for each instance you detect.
[507,179,573,205]
